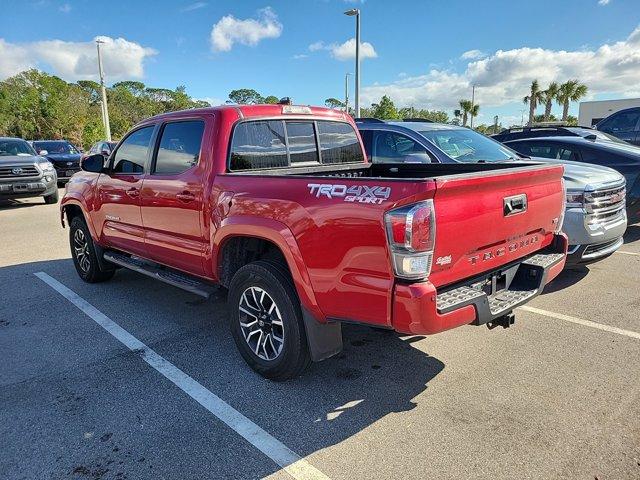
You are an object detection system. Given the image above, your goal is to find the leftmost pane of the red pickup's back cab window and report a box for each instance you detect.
[230,120,289,170]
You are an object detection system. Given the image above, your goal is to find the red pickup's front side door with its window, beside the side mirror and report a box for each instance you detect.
[94,125,155,256]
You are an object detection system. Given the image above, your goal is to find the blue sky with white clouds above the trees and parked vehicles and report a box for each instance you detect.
[0,0,640,125]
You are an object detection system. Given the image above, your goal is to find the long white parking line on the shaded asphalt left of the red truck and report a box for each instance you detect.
[34,272,329,480]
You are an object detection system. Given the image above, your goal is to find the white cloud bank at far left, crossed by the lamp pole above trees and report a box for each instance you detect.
[0,37,158,82]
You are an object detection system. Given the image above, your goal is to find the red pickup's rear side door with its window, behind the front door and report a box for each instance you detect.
[140,119,208,275]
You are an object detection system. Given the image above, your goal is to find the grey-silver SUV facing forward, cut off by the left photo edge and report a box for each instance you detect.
[0,137,58,204]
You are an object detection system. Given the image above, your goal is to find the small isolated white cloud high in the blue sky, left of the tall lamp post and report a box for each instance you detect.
[211,7,282,52]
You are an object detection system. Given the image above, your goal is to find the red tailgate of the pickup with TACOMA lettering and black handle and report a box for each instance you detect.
[429,165,565,287]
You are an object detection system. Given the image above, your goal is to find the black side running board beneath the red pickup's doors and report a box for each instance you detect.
[104,251,218,298]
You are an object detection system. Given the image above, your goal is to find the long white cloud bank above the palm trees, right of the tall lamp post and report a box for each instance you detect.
[362,27,640,109]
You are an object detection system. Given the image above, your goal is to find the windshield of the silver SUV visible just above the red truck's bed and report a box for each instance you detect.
[420,129,517,163]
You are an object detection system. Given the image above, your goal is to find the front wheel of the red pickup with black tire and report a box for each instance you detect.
[69,217,115,283]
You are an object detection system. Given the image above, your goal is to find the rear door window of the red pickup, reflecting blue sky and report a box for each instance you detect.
[154,120,204,175]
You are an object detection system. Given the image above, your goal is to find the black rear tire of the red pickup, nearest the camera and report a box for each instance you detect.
[227,260,311,381]
